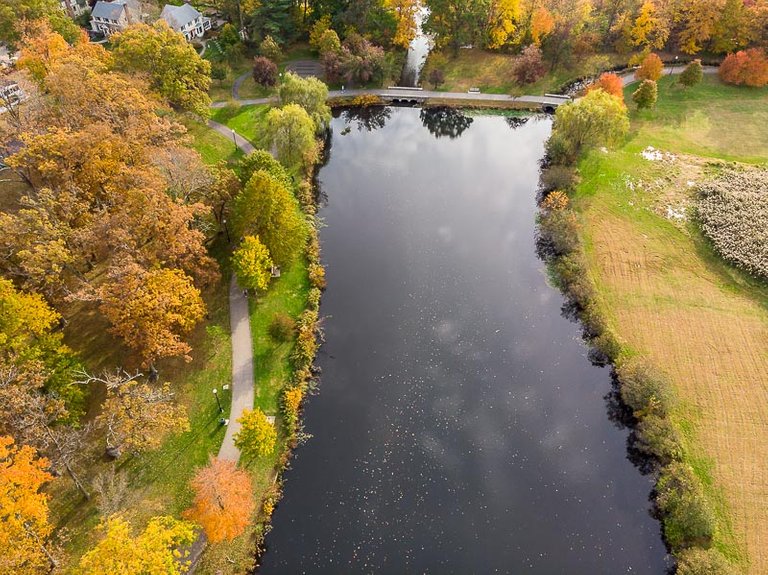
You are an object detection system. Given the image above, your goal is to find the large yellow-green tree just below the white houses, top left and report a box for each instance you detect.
[110,20,211,117]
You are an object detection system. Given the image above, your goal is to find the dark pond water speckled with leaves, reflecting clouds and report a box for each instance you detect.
[260,109,665,575]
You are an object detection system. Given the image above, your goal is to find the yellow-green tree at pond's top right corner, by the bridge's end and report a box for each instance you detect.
[555,90,629,160]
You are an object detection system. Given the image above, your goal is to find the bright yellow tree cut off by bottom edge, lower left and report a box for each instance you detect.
[78,515,195,575]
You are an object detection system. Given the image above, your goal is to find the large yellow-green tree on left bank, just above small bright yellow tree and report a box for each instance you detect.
[235,166,307,266]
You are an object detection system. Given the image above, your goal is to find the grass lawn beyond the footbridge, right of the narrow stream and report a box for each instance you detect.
[422,48,619,96]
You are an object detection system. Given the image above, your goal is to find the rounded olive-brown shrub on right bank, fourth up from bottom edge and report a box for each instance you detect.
[616,358,672,418]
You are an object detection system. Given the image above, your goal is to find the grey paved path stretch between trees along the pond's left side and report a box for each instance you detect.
[219,274,255,462]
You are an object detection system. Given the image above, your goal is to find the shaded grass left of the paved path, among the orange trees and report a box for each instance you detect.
[50,246,232,565]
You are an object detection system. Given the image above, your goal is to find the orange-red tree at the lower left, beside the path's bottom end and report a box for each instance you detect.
[184,456,254,543]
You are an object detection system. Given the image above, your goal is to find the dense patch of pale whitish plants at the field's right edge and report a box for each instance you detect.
[696,170,768,279]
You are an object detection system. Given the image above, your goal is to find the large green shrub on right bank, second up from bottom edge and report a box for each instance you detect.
[656,462,715,552]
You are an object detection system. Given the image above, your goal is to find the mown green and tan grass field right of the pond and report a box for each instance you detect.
[574,76,768,574]
